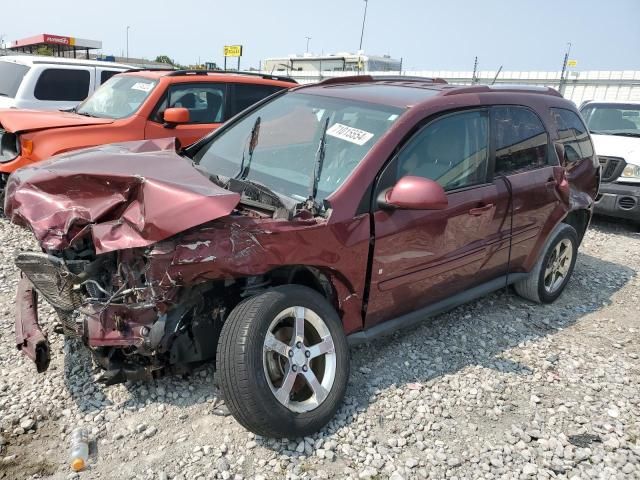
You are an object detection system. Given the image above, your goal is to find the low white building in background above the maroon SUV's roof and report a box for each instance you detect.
[262,52,402,74]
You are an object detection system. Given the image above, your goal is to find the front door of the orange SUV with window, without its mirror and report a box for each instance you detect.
[145,82,227,146]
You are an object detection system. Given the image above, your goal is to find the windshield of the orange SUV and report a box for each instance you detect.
[76,75,156,118]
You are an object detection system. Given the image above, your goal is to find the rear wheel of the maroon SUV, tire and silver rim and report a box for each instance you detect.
[513,223,578,303]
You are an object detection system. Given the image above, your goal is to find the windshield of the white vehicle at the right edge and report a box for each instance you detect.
[580,103,640,136]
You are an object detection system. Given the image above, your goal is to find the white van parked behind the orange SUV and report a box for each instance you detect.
[0,55,131,110]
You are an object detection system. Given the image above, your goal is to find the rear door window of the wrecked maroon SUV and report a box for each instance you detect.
[492,106,548,174]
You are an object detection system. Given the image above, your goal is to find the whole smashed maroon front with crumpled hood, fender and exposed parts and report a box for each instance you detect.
[6,140,369,383]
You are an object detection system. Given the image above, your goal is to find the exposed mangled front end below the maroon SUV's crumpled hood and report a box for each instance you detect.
[16,241,229,384]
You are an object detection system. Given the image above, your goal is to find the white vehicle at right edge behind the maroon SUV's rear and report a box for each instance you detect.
[580,102,640,225]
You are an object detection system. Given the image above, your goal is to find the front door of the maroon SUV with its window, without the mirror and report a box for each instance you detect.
[366,109,505,327]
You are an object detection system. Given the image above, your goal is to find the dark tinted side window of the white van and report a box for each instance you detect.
[34,68,91,102]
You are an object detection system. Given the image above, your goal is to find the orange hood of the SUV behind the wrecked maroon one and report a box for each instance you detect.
[0,109,114,133]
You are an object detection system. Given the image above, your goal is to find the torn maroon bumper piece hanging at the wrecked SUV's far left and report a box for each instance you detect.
[16,276,51,373]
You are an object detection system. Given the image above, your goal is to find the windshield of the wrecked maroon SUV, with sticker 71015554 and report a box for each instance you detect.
[194,92,404,202]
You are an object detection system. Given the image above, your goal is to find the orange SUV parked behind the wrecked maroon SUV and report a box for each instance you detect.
[0,70,296,190]
